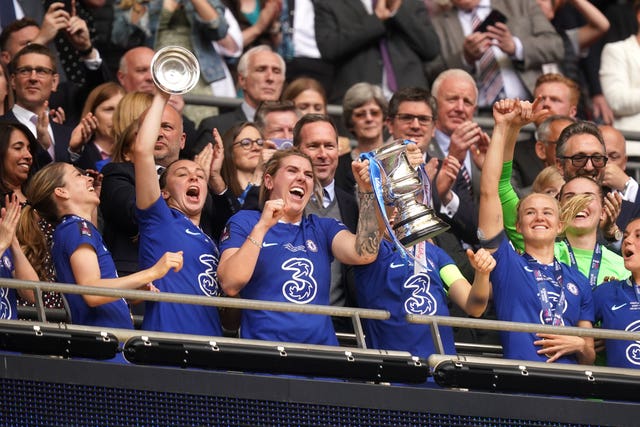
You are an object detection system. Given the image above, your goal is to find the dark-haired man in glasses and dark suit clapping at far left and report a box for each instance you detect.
[3,44,75,167]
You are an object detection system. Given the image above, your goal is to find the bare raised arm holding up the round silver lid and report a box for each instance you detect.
[134,90,169,209]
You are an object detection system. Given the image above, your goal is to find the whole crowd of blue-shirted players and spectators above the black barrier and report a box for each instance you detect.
[0,0,640,376]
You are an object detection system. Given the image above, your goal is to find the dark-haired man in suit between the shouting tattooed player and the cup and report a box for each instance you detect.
[293,114,358,331]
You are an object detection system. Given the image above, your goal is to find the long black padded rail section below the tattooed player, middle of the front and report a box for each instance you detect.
[123,337,429,383]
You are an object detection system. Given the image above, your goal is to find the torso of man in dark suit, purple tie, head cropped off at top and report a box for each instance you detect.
[314,0,439,103]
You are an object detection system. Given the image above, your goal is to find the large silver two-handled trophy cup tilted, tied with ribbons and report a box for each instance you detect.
[374,139,449,247]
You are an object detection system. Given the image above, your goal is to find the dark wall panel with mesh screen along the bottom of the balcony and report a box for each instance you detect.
[0,355,640,427]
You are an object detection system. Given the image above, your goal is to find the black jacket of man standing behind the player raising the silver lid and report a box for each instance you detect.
[100,162,237,275]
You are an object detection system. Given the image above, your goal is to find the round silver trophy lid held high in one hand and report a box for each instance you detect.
[151,46,200,95]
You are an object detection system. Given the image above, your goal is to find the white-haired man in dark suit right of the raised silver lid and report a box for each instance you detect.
[193,45,286,152]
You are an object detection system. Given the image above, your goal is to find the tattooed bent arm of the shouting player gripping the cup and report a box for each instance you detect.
[331,160,383,265]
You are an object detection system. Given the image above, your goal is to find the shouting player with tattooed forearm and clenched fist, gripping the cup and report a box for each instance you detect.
[218,149,382,345]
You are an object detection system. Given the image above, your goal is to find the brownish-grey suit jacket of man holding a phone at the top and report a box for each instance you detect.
[426,0,564,93]
